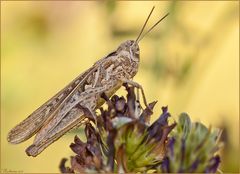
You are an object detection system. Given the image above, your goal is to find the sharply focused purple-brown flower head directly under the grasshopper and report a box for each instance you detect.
[60,85,176,172]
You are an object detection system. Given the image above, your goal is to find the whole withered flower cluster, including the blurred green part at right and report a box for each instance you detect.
[60,84,220,173]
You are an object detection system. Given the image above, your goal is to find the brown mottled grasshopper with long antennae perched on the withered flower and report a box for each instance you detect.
[7,7,168,157]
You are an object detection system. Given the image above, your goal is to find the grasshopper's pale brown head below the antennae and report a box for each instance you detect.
[117,40,140,62]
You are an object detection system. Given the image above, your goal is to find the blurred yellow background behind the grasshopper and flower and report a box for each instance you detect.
[1,1,239,173]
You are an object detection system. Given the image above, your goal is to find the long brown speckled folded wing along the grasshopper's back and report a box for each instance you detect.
[7,66,96,144]
